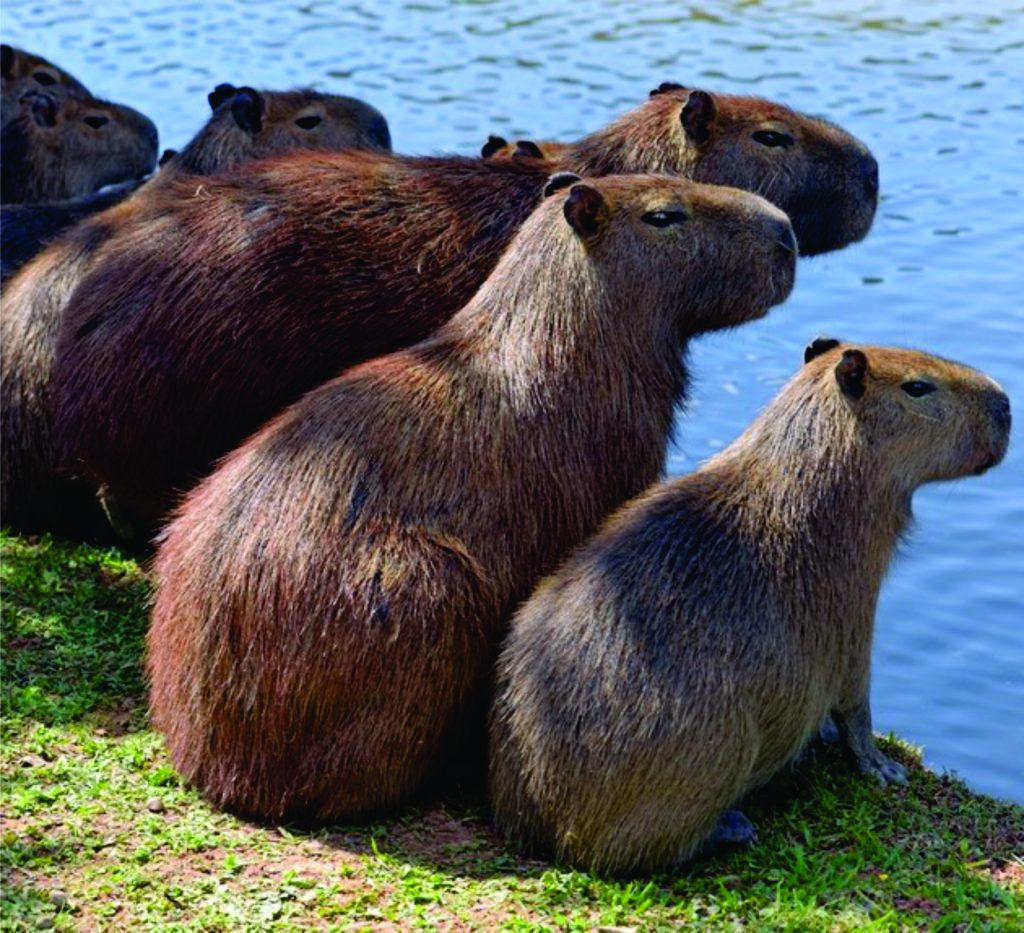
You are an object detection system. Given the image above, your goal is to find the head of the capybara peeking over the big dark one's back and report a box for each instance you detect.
[171,84,391,175]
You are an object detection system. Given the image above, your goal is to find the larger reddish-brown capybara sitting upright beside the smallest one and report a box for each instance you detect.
[148,174,796,821]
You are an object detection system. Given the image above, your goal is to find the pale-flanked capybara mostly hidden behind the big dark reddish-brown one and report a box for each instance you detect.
[0,84,390,534]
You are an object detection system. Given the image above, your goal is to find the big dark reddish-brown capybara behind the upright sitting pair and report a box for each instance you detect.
[55,83,877,526]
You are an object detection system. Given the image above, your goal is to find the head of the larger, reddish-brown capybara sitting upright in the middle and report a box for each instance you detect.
[546,172,797,336]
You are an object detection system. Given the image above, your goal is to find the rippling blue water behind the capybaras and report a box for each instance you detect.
[2,0,1024,802]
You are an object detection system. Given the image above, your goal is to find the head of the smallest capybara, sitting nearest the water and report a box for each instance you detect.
[795,338,1010,492]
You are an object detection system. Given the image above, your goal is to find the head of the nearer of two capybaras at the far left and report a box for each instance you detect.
[0,91,158,203]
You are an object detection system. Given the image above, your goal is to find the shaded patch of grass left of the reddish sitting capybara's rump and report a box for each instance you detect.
[0,534,150,731]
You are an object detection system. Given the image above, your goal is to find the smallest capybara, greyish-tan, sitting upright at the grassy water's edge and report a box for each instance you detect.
[490,340,1010,873]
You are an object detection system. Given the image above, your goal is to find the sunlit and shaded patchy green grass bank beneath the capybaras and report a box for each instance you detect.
[0,536,1024,933]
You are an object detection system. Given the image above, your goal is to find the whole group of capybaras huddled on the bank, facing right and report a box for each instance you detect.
[0,45,1010,873]
